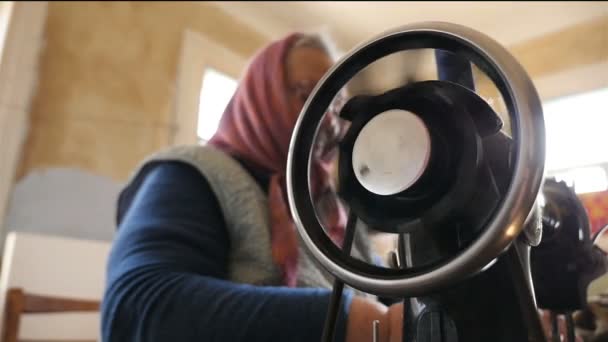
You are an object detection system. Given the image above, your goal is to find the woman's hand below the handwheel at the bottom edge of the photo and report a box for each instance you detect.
[346,297,403,342]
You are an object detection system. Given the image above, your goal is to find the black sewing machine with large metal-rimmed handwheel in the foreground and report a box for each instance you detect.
[287,22,604,342]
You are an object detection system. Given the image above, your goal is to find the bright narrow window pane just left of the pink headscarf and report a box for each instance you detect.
[197,68,237,142]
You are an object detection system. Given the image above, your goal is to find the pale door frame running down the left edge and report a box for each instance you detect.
[0,1,48,239]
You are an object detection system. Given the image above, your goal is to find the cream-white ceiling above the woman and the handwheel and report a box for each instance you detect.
[214,1,608,50]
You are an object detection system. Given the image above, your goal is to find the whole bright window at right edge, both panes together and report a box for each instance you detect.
[543,88,608,193]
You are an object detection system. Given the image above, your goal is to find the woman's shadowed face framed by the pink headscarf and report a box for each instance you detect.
[287,47,332,107]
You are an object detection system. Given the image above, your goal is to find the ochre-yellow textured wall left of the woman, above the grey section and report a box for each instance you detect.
[18,2,266,180]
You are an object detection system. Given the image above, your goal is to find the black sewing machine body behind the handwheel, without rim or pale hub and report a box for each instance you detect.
[340,78,543,342]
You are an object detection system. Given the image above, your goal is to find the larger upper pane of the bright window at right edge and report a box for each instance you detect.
[543,88,608,171]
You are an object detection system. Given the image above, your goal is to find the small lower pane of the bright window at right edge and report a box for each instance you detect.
[554,166,608,194]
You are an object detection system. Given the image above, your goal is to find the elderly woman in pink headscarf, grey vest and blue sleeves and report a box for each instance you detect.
[102,34,402,342]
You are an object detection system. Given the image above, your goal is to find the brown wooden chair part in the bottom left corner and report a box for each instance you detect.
[2,288,100,342]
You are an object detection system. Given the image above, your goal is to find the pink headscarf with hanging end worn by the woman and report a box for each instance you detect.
[209,33,346,287]
